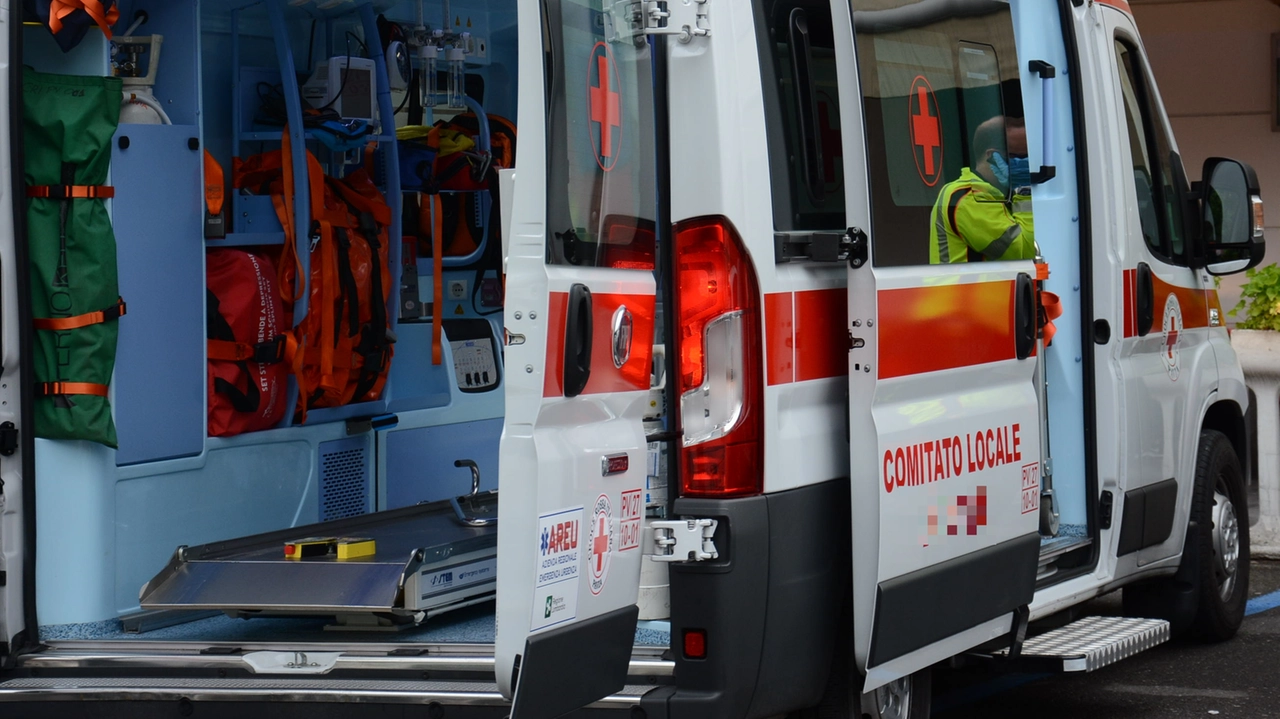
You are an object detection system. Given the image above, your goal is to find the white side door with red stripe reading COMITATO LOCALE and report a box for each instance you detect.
[833,0,1041,691]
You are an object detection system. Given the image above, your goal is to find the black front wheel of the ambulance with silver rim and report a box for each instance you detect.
[1124,430,1249,642]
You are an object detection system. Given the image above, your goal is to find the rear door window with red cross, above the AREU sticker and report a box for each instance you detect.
[545,0,657,270]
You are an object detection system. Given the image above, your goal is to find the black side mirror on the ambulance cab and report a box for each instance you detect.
[1199,157,1266,275]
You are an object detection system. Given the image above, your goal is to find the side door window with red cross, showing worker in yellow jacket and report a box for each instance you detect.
[854,0,1034,266]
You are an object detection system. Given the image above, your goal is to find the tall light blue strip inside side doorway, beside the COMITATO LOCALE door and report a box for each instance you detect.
[1012,1,1087,526]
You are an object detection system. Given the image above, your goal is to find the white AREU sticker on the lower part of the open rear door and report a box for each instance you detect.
[530,507,582,632]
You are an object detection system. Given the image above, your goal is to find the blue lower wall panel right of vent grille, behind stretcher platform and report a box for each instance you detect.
[385,417,502,509]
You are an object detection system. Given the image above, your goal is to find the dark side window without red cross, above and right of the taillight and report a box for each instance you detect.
[756,0,845,232]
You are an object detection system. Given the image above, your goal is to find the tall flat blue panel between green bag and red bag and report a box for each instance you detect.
[111,125,206,464]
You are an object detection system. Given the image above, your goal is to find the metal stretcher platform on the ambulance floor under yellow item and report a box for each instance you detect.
[140,493,498,624]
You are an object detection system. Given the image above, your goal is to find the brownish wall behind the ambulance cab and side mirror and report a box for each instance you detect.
[1130,0,1280,324]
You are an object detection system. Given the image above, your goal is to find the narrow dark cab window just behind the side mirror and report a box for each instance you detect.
[1116,40,1185,261]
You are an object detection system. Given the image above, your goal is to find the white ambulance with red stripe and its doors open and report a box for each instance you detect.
[0,0,1263,719]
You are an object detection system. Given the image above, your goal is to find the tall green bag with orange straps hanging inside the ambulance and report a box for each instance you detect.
[23,68,124,448]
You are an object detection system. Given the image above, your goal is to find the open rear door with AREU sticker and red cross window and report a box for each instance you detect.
[497,0,657,719]
